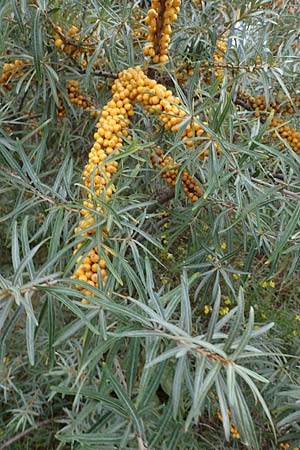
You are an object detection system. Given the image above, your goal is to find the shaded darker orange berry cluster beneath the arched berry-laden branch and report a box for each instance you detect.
[150,147,202,202]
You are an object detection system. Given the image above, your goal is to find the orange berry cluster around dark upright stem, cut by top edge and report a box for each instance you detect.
[144,0,181,64]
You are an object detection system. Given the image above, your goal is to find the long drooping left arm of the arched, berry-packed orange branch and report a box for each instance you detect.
[74,67,142,303]
